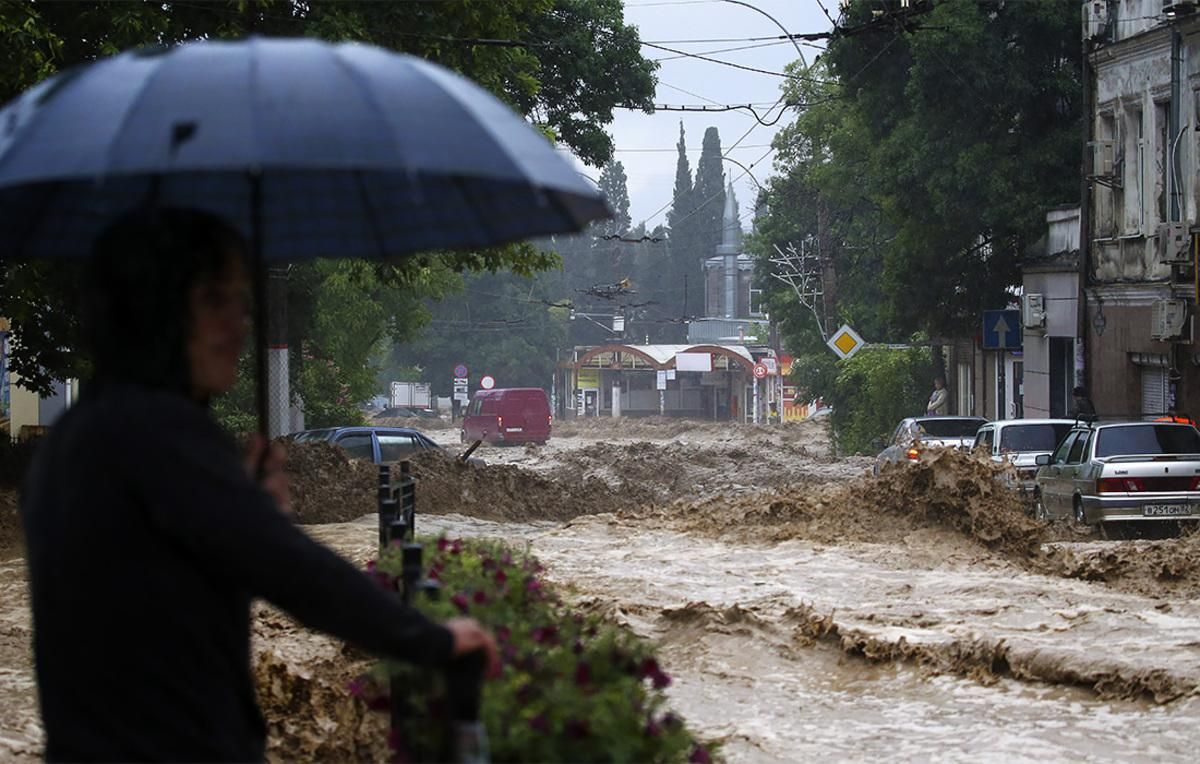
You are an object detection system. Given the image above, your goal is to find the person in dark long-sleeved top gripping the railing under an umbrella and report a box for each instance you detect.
[22,209,498,760]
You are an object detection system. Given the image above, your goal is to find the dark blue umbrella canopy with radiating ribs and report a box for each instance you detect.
[0,37,608,260]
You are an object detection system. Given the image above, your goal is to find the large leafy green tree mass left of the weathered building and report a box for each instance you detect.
[751,0,1081,351]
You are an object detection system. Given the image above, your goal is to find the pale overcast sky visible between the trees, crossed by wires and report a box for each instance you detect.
[564,0,838,228]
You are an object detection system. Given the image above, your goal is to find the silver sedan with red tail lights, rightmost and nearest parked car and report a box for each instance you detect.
[1037,422,1200,535]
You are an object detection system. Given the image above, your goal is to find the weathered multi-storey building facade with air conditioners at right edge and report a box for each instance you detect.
[1084,0,1200,416]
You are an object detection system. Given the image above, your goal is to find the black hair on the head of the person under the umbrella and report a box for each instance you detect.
[84,207,246,395]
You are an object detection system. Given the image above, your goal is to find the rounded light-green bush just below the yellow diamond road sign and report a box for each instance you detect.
[824,348,934,453]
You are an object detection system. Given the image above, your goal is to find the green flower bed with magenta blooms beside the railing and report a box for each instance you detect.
[369,539,708,763]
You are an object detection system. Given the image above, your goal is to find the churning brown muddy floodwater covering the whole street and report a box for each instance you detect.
[0,421,1200,762]
